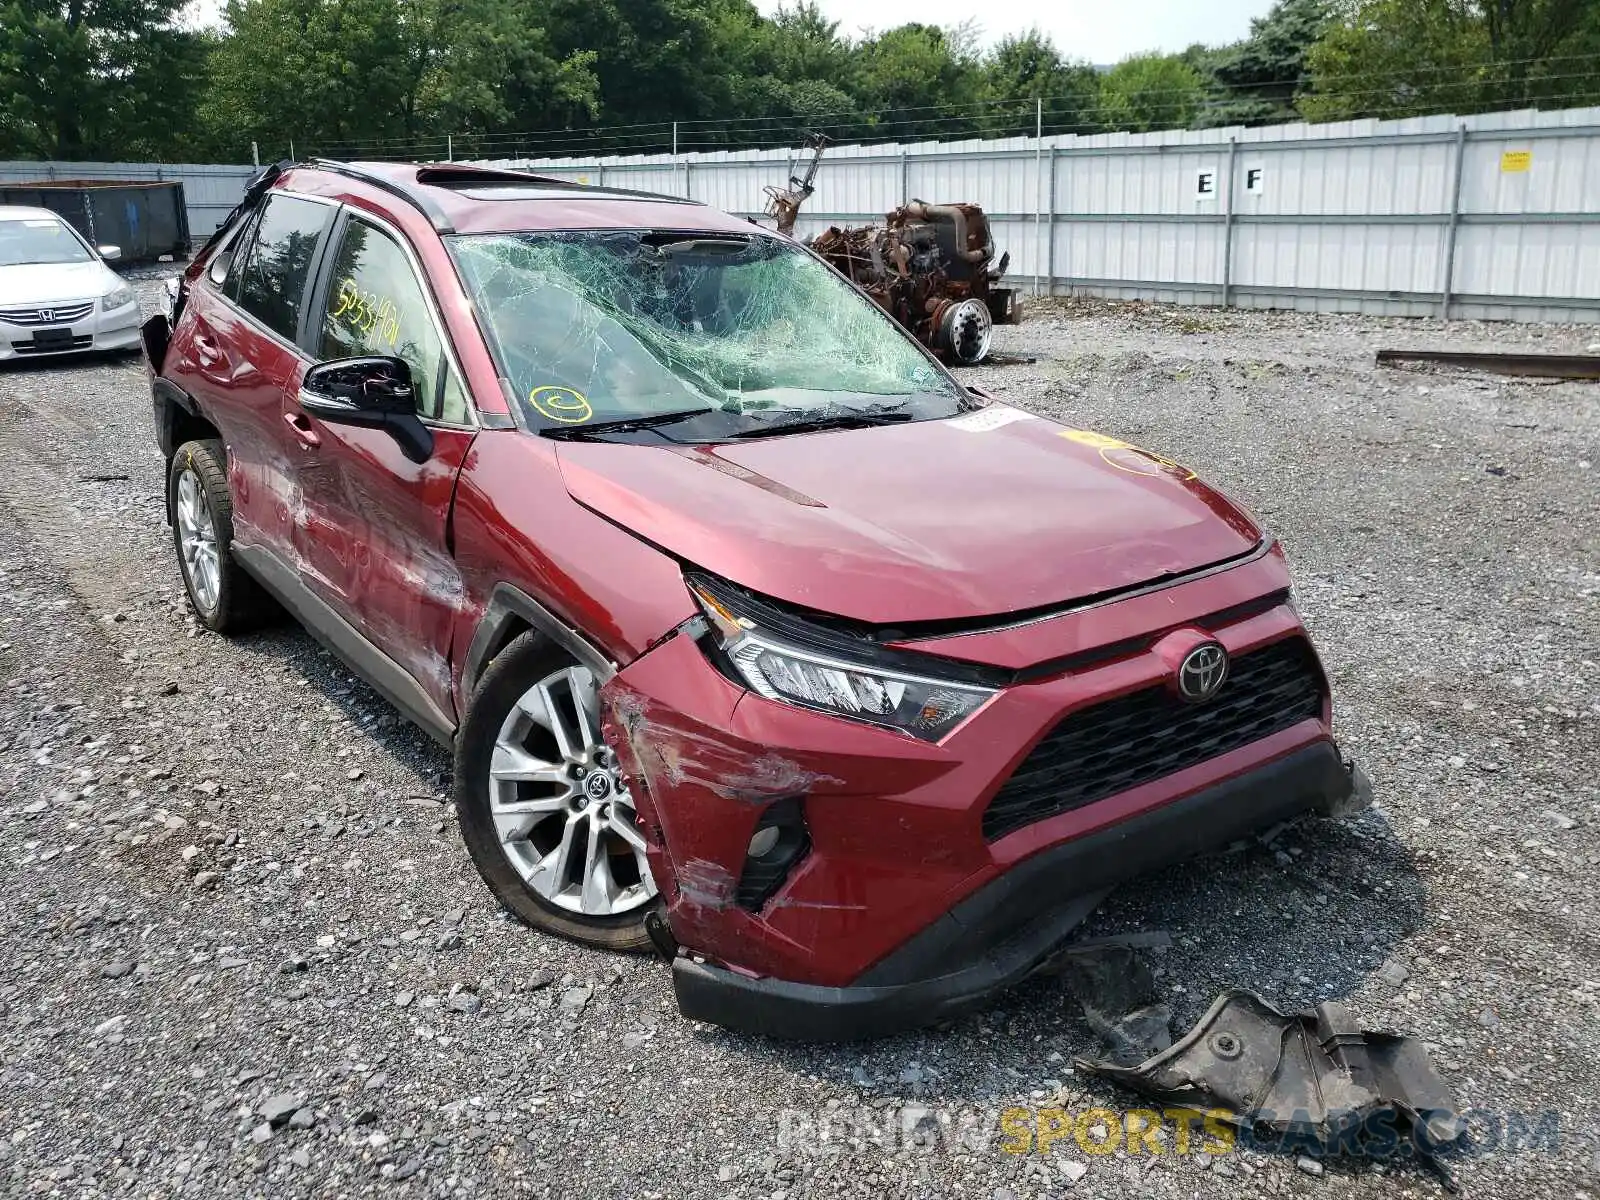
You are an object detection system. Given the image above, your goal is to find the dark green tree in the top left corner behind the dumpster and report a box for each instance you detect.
[0,0,208,158]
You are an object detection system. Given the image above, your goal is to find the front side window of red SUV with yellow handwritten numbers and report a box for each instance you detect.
[317,216,467,424]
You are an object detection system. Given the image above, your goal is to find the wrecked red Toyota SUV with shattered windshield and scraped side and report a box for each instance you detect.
[144,162,1370,1038]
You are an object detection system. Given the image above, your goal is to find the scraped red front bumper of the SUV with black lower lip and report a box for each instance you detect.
[602,563,1371,1040]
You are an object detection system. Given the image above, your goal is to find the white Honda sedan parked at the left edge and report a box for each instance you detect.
[0,206,139,362]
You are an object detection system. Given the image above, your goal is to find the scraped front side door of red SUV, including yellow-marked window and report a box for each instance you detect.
[283,211,475,714]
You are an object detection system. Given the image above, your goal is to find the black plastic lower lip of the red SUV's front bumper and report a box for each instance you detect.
[672,742,1371,1042]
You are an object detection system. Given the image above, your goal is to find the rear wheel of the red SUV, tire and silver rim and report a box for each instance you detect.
[166,440,280,634]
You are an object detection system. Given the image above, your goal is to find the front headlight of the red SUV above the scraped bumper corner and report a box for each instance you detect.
[688,576,995,742]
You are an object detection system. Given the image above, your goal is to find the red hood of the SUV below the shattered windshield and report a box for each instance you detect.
[557,405,1261,624]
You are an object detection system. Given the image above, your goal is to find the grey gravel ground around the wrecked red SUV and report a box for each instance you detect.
[0,280,1600,1200]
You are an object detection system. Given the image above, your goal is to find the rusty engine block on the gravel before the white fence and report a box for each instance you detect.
[811,200,1022,366]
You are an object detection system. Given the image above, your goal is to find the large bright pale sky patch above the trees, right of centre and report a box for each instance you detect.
[755,0,1272,64]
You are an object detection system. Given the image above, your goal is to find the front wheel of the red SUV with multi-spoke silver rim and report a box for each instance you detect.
[454,632,661,950]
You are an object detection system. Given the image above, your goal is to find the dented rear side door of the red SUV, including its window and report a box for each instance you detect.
[168,192,338,562]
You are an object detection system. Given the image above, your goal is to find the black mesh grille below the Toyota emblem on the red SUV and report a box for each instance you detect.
[984,637,1323,842]
